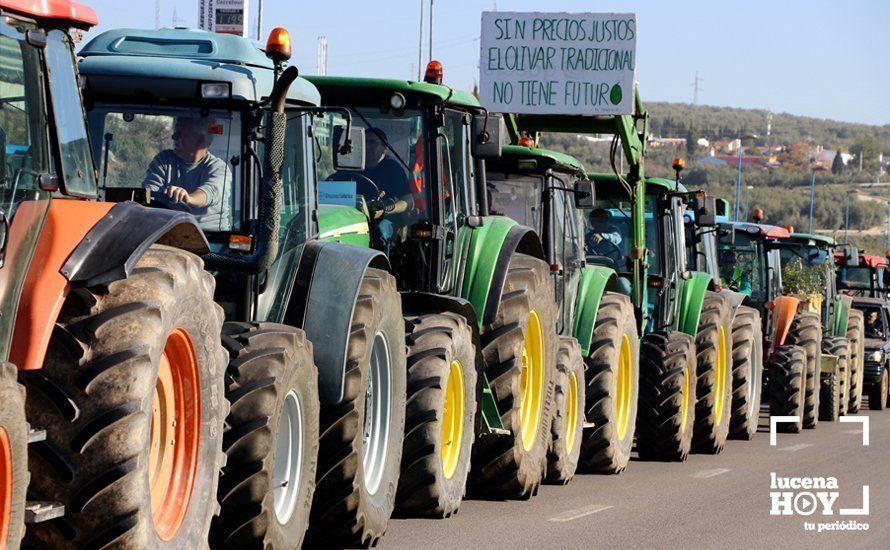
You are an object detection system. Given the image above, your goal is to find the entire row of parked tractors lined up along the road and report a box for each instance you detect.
[0,0,890,548]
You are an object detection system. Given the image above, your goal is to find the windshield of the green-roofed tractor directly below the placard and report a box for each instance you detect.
[486,172,544,232]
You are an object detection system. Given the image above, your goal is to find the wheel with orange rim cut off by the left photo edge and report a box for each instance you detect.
[0,362,28,548]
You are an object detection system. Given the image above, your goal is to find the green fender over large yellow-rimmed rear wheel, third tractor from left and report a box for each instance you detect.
[461,216,546,330]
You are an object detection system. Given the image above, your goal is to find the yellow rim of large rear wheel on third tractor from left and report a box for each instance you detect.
[519,310,544,451]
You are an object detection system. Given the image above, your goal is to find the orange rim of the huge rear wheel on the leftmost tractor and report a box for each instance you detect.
[149,328,201,541]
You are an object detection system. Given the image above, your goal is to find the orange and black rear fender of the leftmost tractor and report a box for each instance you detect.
[10,199,209,370]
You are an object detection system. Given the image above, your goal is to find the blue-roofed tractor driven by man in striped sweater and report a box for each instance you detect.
[80,29,406,547]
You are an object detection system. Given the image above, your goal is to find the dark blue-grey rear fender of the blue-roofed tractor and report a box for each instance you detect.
[284,240,390,405]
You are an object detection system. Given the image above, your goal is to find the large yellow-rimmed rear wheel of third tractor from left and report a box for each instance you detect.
[471,253,559,498]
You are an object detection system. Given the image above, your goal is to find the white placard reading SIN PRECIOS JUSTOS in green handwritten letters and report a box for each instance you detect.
[479,11,637,115]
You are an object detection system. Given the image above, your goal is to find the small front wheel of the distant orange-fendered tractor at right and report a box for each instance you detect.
[768,345,807,433]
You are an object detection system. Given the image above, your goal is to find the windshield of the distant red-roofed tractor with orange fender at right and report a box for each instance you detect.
[717,229,767,302]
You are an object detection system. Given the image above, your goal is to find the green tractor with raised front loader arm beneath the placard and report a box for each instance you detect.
[516,101,732,460]
